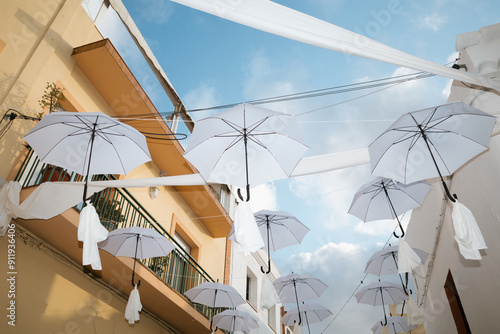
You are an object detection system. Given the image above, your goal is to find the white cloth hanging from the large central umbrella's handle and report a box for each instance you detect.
[231,202,264,255]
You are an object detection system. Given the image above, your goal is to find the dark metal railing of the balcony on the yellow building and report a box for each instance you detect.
[16,149,225,319]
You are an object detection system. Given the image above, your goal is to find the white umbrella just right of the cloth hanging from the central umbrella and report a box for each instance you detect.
[229,210,309,274]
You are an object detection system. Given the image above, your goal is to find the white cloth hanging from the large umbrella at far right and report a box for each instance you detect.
[451,201,488,260]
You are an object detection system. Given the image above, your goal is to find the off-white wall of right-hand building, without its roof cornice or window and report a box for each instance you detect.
[406,45,500,333]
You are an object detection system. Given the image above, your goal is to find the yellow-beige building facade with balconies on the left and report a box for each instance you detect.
[0,0,239,333]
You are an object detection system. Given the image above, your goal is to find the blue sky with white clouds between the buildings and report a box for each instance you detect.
[82,0,500,334]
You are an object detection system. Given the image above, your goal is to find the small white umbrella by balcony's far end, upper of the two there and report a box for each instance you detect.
[184,282,245,330]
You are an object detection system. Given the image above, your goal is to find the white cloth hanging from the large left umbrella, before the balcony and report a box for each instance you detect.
[78,201,109,270]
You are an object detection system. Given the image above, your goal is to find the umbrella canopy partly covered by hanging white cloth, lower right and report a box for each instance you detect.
[365,246,429,276]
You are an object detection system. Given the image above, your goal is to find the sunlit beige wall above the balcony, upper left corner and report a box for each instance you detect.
[0,0,102,178]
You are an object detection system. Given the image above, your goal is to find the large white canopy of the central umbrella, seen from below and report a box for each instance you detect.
[184,103,308,201]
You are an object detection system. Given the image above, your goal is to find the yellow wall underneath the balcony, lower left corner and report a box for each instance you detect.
[0,226,180,334]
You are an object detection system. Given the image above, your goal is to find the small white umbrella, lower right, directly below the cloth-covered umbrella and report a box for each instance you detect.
[354,282,407,323]
